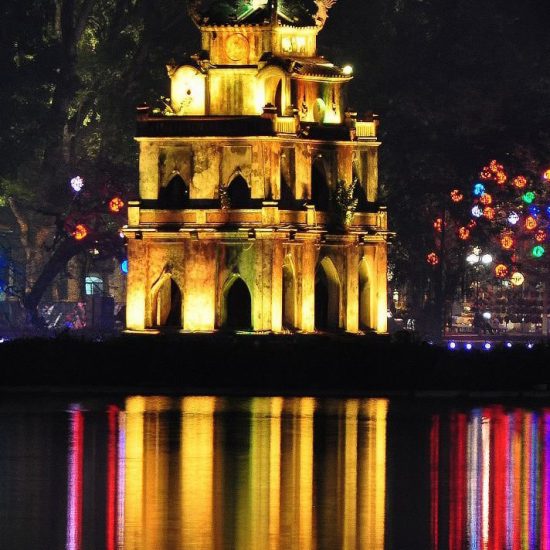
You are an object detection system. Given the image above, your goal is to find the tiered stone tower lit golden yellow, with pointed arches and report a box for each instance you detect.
[124,0,387,333]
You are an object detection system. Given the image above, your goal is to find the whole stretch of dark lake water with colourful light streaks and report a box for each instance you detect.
[0,396,550,550]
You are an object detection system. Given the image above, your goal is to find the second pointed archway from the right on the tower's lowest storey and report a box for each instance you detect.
[315,257,340,330]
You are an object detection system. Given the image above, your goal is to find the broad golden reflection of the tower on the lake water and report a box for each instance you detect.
[122,397,388,550]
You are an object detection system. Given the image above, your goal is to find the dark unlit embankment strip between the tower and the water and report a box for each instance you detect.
[0,334,550,395]
